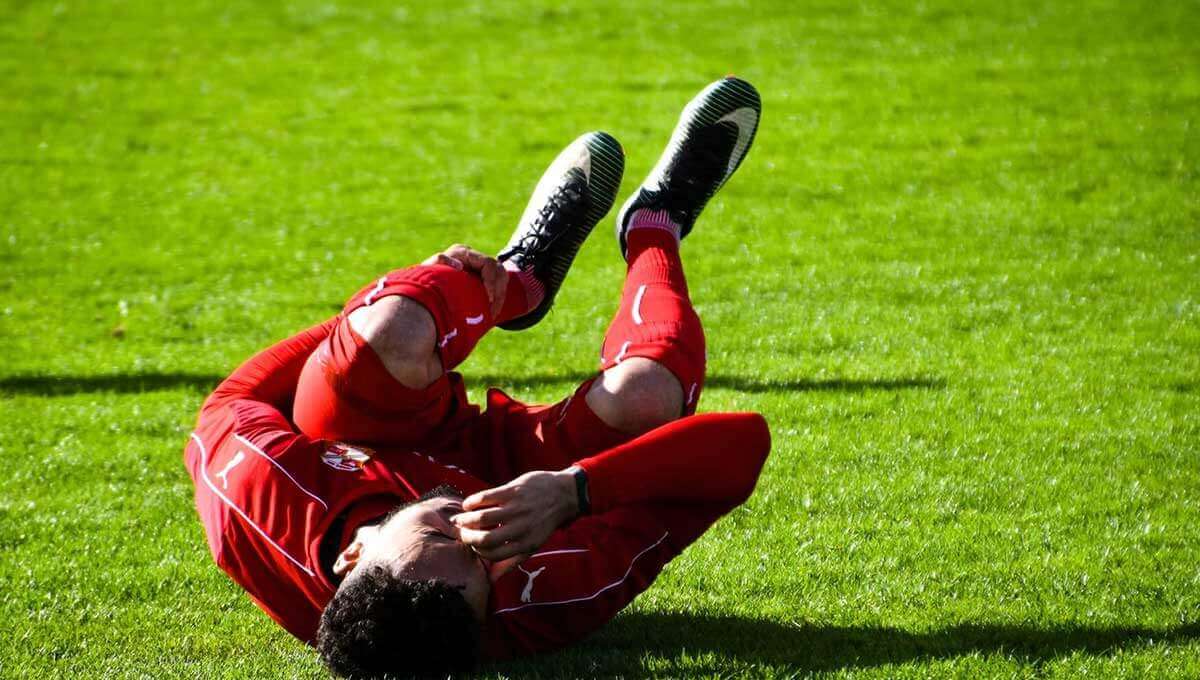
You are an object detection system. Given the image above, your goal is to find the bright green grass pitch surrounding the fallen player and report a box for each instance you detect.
[0,0,1200,678]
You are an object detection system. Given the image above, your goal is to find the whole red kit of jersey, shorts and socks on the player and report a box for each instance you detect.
[184,250,770,658]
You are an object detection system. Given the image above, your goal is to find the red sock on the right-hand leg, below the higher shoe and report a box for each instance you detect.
[600,211,706,414]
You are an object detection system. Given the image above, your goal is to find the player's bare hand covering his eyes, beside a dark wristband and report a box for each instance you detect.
[450,469,580,562]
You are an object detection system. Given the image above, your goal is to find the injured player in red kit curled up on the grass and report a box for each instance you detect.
[185,78,770,675]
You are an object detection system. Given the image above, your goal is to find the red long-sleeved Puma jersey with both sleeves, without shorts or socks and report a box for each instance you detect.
[184,321,769,658]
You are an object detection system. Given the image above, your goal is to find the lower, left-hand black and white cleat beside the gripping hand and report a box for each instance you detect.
[497,132,625,331]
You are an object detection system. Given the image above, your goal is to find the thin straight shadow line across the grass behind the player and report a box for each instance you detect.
[0,372,946,397]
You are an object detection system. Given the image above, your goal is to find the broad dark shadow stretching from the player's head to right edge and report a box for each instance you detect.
[496,612,1200,676]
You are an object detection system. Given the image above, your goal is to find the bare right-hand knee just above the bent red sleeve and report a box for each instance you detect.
[587,357,684,434]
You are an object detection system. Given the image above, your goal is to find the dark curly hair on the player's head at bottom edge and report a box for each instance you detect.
[317,565,479,678]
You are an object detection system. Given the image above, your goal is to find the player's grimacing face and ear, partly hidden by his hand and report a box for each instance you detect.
[359,495,491,621]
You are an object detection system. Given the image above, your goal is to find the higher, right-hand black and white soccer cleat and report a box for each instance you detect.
[617,76,762,257]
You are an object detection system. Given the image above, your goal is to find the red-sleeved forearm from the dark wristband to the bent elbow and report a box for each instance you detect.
[578,413,770,512]
